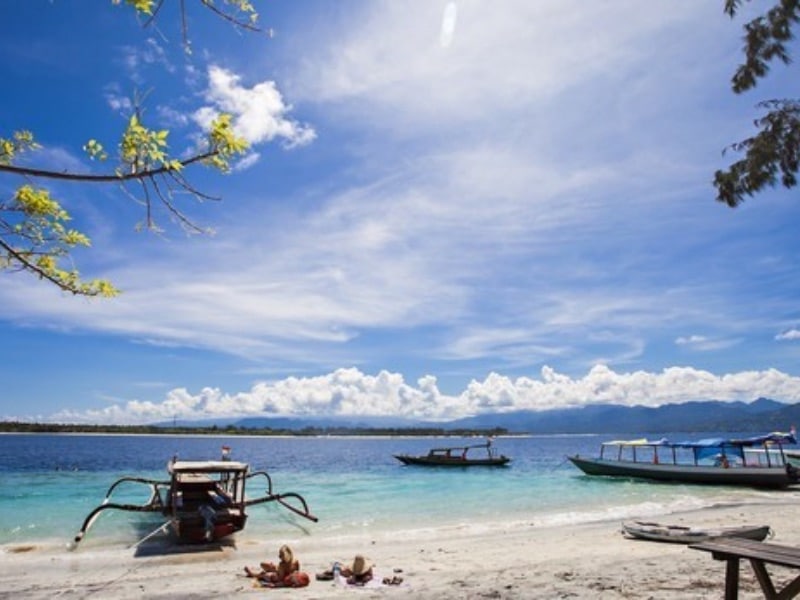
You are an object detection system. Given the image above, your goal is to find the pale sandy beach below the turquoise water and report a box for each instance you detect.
[0,501,800,600]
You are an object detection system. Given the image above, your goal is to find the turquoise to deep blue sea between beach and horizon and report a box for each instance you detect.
[0,432,800,547]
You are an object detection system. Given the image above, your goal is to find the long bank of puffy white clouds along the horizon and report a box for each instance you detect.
[45,365,800,423]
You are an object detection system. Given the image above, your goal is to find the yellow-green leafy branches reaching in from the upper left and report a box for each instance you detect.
[0,0,258,297]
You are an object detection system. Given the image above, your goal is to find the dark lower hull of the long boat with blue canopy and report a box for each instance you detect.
[567,456,800,488]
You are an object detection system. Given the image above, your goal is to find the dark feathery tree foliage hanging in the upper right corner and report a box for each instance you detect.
[714,0,800,207]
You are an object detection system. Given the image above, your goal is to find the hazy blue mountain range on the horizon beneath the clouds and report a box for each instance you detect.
[172,398,800,434]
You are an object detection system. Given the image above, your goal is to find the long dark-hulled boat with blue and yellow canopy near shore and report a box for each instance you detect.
[567,431,800,488]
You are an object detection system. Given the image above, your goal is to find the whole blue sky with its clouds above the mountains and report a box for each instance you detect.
[0,0,800,427]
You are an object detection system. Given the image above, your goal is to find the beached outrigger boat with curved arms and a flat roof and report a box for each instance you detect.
[72,447,317,547]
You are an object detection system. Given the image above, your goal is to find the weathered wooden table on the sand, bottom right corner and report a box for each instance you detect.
[689,538,800,600]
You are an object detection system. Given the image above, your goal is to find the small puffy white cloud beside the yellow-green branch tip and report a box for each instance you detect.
[193,65,316,147]
